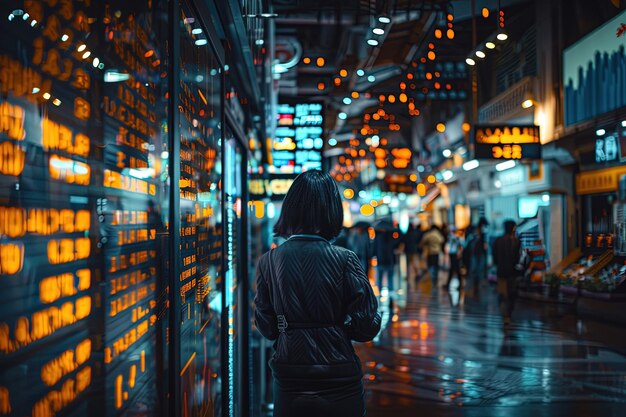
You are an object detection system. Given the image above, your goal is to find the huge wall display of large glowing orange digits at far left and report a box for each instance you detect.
[0,0,169,416]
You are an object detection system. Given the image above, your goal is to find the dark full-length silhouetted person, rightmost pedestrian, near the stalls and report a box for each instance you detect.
[493,220,521,326]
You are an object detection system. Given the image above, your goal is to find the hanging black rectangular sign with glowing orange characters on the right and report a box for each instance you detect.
[474,125,541,160]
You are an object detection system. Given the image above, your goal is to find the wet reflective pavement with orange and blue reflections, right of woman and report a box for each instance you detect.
[358,280,626,417]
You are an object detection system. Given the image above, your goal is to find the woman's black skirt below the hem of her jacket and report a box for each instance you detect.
[273,379,365,417]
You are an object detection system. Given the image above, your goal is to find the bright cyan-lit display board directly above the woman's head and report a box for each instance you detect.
[271,103,324,174]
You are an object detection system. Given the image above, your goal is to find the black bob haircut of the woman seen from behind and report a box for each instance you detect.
[274,170,343,240]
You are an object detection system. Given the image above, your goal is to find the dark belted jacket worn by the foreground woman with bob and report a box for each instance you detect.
[255,236,381,387]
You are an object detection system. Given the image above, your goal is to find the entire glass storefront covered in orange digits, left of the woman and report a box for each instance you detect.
[0,0,260,416]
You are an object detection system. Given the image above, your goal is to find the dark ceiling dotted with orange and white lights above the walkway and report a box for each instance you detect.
[272,0,525,184]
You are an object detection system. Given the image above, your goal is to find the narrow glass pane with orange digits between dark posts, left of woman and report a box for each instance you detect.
[176,1,224,416]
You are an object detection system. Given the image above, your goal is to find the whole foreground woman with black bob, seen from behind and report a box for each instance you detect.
[254,170,381,417]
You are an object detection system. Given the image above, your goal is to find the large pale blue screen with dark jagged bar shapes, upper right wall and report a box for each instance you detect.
[563,11,626,126]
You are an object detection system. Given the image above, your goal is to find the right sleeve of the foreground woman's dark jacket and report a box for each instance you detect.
[344,252,381,342]
